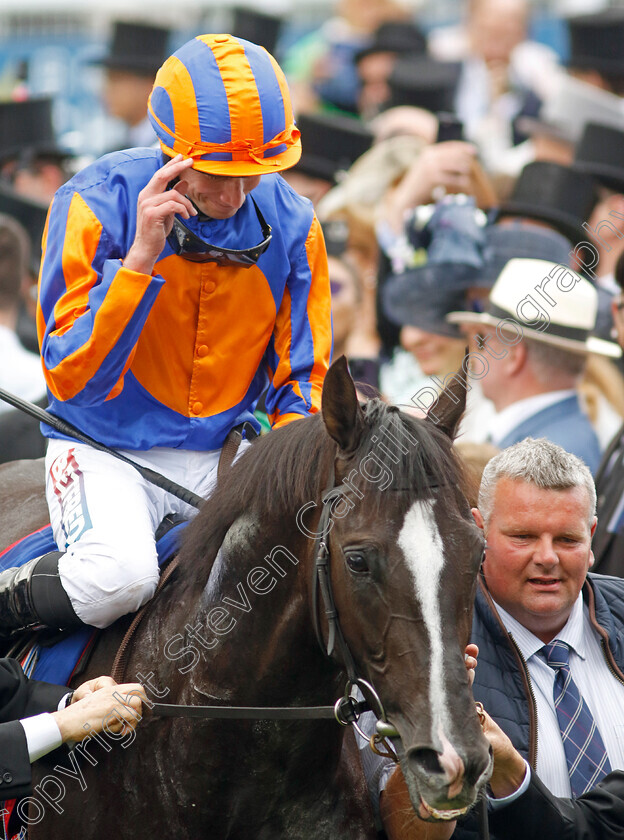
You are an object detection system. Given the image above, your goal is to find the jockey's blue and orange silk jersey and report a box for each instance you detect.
[37,149,331,450]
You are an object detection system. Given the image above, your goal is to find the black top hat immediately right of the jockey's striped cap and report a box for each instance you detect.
[293,113,373,182]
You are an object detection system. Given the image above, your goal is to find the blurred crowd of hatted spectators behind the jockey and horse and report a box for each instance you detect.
[0,0,624,836]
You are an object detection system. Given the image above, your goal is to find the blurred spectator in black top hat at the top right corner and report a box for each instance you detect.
[567,7,624,96]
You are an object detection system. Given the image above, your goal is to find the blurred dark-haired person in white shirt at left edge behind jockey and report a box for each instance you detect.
[0,214,46,463]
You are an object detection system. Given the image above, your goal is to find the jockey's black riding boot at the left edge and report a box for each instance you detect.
[0,551,82,638]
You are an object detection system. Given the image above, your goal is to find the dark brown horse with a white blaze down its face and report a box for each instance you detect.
[0,357,491,840]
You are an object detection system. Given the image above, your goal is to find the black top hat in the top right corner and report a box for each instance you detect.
[567,8,624,75]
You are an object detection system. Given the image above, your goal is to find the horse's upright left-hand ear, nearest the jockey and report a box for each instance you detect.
[321,356,364,452]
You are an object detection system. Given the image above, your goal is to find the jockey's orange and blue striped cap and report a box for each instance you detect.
[148,35,301,176]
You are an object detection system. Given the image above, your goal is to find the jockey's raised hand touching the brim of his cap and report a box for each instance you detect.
[123,155,197,274]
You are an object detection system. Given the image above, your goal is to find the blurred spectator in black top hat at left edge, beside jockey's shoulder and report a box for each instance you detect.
[0,99,71,204]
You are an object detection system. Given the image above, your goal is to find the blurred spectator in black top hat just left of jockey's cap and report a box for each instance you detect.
[98,21,170,151]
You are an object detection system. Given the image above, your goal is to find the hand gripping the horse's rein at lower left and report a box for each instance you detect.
[52,677,147,742]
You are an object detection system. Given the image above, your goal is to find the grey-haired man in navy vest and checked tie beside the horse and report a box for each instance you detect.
[358,438,624,840]
